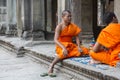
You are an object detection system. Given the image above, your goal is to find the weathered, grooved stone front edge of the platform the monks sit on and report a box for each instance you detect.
[0,40,119,80]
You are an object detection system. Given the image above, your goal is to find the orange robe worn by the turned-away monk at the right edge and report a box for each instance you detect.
[90,23,120,66]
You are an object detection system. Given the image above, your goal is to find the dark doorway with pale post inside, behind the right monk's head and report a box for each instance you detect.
[93,0,114,40]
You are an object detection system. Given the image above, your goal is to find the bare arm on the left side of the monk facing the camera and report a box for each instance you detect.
[54,25,68,56]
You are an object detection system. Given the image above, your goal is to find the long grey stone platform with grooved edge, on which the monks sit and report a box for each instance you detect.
[0,36,120,80]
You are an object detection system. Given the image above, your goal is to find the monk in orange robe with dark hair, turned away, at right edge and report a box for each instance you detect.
[90,12,120,66]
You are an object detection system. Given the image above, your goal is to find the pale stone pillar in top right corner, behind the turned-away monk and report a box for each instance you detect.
[114,0,120,22]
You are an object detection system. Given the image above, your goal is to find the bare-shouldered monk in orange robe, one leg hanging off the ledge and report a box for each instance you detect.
[48,10,88,73]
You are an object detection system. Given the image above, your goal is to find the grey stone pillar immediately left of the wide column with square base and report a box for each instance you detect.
[22,0,32,39]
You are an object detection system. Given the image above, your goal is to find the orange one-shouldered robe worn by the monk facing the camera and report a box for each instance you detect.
[56,23,88,59]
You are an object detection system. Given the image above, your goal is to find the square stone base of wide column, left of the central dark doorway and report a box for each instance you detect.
[32,31,45,41]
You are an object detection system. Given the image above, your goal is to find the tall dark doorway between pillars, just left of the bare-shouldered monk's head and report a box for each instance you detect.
[45,0,57,40]
